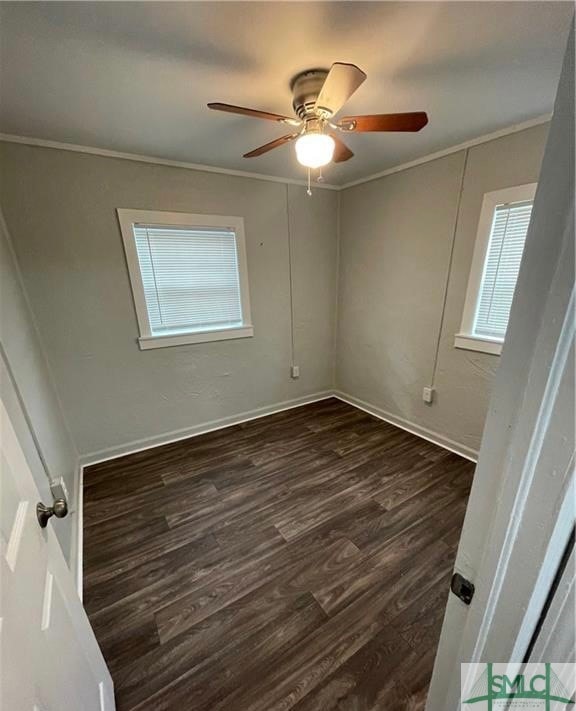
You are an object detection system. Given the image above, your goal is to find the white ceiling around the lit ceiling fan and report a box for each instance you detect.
[0,2,573,184]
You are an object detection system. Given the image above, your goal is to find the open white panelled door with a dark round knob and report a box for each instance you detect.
[0,400,115,711]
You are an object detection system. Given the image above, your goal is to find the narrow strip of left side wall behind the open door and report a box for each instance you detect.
[0,211,78,561]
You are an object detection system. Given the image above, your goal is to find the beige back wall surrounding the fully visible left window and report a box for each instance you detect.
[0,143,337,455]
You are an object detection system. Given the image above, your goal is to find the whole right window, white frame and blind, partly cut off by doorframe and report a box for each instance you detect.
[454,183,536,354]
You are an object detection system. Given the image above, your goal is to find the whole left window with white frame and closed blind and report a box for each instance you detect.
[118,209,254,349]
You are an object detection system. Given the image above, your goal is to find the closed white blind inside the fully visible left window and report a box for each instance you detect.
[133,224,243,335]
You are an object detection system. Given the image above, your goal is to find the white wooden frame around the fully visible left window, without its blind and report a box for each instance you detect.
[116,208,254,350]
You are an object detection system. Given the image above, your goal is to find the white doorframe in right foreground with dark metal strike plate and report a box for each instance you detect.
[426,25,576,711]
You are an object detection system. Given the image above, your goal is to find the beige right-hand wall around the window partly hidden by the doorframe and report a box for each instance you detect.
[336,125,548,454]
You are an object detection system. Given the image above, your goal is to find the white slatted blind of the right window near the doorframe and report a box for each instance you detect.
[474,201,532,339]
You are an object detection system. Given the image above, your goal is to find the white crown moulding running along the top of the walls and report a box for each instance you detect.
[0,113,552,191]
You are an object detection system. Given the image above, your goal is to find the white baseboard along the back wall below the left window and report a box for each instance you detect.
[80,390,334,467]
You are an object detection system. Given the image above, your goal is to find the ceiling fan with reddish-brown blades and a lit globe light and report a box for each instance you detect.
[208,62,428,175]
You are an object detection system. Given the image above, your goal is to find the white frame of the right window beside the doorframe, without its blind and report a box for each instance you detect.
[454,183,538,355]
